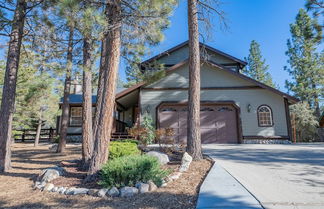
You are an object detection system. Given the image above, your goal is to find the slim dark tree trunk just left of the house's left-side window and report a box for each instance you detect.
[57,27,74,153]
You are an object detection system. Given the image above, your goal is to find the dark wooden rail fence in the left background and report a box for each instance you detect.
[14,128,57,142]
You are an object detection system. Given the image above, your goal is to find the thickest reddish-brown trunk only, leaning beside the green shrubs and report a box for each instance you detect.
[88,0,121,179]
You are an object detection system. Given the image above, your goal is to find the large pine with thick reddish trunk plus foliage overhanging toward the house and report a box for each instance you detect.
[87,0,176,177]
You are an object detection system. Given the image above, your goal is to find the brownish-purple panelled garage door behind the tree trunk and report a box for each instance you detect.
[158,105,238,144]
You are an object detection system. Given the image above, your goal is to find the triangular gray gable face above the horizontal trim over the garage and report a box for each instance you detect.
[147,63,255,88]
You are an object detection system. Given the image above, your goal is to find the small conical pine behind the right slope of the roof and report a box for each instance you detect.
[243,40,275,87]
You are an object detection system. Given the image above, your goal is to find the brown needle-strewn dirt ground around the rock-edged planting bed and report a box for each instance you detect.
[0,143,212,209]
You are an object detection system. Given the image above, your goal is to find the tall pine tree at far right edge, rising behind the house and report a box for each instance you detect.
[285,9,324,117]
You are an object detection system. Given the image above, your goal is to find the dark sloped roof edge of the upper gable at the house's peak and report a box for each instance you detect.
[142,41,247,66]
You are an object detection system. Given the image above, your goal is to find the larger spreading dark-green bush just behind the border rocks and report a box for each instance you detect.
[99,155,169,188]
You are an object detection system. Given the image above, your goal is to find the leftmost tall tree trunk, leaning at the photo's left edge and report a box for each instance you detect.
[0,0,27,172]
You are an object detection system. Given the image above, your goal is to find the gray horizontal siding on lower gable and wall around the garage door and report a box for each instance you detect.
[141,65,288,136]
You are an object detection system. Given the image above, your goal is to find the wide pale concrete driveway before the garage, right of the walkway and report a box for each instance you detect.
[203,144,324,209]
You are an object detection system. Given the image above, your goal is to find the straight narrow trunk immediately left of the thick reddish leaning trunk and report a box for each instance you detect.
[82,38,93,168]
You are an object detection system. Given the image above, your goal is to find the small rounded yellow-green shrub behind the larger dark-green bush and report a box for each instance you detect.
[109,140,141,159]
